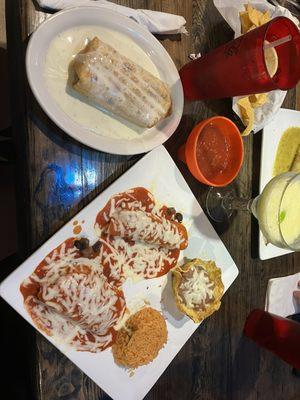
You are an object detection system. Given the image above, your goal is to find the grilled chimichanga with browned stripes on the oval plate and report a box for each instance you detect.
[73,37,172,128]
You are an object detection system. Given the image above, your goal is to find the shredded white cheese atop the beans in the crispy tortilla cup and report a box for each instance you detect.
[179,267,214,309]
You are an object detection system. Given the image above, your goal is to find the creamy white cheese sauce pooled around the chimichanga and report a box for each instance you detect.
[44,26,160,139]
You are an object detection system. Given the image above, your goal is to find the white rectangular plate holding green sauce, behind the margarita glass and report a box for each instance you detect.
[259,108,300,260]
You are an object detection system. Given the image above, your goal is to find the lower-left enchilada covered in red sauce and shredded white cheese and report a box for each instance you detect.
[23,243,125,351]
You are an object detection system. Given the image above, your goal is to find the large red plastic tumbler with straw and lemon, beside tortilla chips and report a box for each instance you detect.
[180,17,300,100]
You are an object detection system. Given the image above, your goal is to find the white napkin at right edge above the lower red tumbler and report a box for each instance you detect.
[265,272,300,317]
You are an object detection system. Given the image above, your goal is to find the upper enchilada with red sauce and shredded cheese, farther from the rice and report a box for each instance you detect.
[95,188,185,286]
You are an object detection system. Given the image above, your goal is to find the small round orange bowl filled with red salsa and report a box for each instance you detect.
[179,116,244,186]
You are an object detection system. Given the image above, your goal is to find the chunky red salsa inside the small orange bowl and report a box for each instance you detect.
[196,123,230,180]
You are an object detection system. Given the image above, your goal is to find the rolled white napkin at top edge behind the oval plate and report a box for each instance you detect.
[37,0,187,34]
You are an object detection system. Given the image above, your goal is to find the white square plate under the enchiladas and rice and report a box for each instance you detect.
[0,146,238,400]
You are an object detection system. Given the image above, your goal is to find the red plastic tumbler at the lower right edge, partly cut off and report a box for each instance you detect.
[244,310,300,370]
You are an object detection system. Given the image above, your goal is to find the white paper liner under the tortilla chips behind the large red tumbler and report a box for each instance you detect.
[214,0,299,133]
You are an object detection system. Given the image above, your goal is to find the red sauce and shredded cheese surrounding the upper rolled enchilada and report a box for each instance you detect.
[95,187,187,286]
